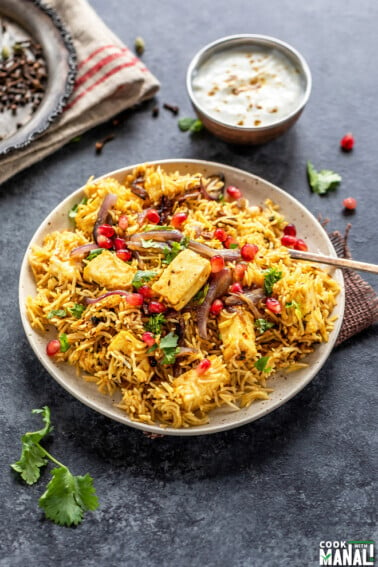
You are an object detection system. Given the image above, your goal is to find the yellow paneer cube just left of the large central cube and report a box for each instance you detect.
[83,250,136,290]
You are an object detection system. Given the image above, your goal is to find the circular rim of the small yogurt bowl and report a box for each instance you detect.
[186,34,312,133]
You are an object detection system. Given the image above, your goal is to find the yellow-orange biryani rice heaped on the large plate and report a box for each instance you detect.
[27,165,339,428]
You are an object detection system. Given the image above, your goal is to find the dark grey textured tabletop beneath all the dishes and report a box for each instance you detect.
[0,0,378,567]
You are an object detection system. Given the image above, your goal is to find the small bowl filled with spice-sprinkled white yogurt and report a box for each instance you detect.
[187,34,311,144]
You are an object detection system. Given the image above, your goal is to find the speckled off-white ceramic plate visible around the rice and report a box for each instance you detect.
[19,160,344,436]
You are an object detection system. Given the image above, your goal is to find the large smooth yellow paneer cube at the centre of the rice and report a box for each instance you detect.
[152,249,211,311]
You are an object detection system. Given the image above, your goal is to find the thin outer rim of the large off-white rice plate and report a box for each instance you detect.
[18,158,345,437]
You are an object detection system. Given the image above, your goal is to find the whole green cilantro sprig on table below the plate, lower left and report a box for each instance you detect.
[11,406,99,526]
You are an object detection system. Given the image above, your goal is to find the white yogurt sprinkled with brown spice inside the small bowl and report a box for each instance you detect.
[192,45,305,128]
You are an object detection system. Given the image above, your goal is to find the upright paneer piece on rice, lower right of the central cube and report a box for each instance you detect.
[218,310,257,360]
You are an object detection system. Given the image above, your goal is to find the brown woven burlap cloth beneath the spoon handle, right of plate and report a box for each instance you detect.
[329,224,378,346]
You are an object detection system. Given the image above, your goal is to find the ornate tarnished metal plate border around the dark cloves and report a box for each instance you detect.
[0,0,76,156]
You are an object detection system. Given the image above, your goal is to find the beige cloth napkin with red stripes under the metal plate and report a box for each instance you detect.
[0,0,159,183]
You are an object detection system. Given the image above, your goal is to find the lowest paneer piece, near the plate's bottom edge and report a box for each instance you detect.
[172,356,230,411]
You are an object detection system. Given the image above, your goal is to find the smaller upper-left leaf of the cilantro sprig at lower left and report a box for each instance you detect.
[11,406,52,484]
